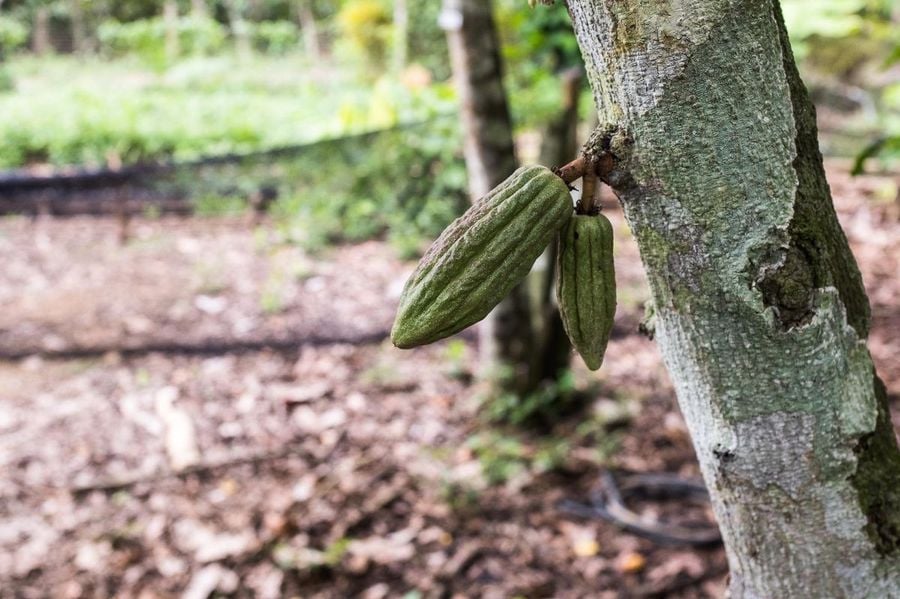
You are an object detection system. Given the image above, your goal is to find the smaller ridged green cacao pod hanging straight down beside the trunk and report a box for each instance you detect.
[556,214,616,370]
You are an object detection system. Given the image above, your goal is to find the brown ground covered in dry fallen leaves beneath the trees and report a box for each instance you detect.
[0,164,900,599]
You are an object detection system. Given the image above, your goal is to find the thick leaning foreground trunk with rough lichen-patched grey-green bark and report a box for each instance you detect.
[568,0,900,598]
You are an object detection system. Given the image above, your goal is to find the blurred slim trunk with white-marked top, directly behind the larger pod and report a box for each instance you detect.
[441,0,535,395]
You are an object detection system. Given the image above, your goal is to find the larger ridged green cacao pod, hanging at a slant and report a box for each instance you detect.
[391,166,572,349]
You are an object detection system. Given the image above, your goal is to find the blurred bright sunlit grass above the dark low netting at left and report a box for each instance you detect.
[0,54,454,168]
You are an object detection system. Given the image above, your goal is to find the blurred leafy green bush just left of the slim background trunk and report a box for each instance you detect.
[275,113,467,257]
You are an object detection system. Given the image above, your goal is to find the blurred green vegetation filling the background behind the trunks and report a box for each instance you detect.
[0,0,900,255]
